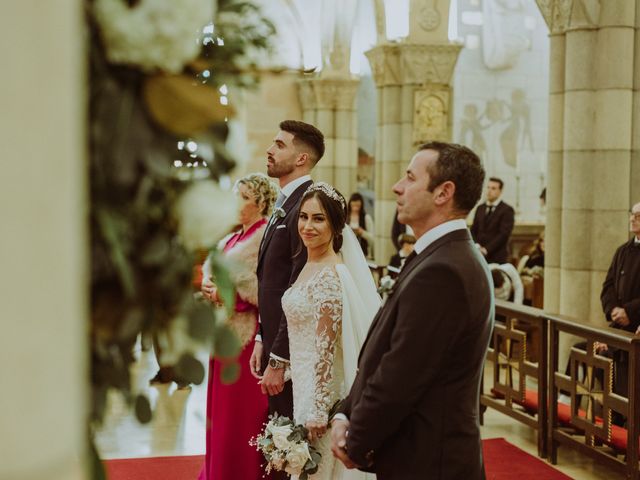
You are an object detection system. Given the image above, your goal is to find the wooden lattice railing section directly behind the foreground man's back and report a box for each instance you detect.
[480,300,547,458]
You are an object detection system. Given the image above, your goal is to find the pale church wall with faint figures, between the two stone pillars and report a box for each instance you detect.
[453,0,549,223]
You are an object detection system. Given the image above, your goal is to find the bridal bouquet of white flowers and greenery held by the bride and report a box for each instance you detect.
[249,414,322,480]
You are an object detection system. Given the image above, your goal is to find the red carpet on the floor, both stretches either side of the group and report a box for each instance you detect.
[104,438,571,480]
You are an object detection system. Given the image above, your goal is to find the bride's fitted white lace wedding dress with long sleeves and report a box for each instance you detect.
[282,258,375,480]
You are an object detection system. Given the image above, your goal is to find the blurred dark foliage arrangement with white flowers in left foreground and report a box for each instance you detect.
[86,0,274,438]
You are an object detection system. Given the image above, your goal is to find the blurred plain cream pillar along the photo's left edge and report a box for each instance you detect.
[0,0,89,480]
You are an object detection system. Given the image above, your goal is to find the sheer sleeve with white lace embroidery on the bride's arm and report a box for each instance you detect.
[311,268,342,423]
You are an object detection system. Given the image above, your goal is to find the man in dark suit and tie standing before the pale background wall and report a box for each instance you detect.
[471,177,515,263]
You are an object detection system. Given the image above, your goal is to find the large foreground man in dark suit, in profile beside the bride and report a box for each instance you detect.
[331,142,494,480]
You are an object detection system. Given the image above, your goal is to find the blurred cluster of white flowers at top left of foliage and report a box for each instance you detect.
[93,0,215,73]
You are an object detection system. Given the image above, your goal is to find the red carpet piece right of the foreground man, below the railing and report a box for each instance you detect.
[482,438,571,480]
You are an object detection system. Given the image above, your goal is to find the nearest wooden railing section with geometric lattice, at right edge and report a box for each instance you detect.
[546,316,640,480]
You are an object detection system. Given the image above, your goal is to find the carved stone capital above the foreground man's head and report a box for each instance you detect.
[366,43,462,87]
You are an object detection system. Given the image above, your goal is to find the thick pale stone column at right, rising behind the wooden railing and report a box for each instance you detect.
[538,0,639,325]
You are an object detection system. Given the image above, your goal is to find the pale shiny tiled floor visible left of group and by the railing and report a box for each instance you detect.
[96,344,624,480]
